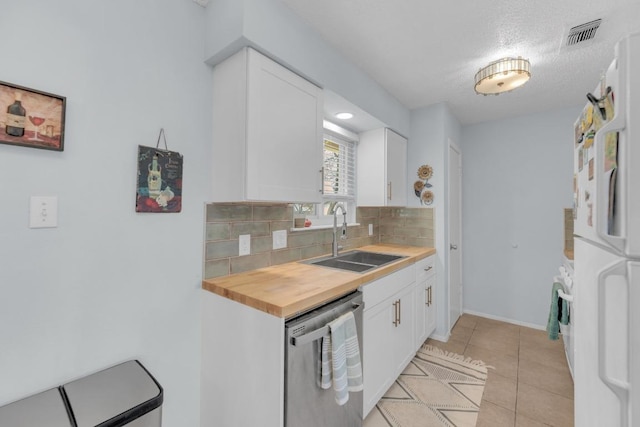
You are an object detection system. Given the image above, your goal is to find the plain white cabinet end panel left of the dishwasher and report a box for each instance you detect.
[200,291,285,427]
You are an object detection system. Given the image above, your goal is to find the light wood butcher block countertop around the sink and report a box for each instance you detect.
[202,244,436,318]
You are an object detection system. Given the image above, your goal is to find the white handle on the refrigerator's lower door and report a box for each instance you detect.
[596,261,629,426]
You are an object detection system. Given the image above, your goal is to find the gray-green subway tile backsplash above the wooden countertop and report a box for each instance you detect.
[204,203,434,279]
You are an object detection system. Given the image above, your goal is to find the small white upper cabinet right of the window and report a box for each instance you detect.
[358,128,407,206]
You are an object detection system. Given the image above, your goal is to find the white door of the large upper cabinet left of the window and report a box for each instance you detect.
[246,49,323,203]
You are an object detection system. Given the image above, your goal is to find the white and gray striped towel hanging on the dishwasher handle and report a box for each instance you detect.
[319,312,362,405]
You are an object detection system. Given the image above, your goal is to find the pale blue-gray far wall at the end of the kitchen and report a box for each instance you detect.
[462,108,580,327]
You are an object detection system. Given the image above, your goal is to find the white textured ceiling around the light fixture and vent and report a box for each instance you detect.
[281,0,640,124]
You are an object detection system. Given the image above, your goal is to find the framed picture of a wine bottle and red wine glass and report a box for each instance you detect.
[0,82,66,151]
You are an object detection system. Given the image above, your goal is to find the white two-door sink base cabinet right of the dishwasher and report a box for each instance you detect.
[362,265,415,417]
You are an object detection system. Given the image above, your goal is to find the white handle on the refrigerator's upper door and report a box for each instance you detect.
[593,74,627,252]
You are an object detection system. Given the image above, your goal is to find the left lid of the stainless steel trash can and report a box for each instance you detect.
[0,388,72,427]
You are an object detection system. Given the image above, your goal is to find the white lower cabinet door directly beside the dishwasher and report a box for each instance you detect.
[362,299,396,417]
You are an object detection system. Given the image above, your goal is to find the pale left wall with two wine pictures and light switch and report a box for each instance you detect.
[0,0,211,427]
